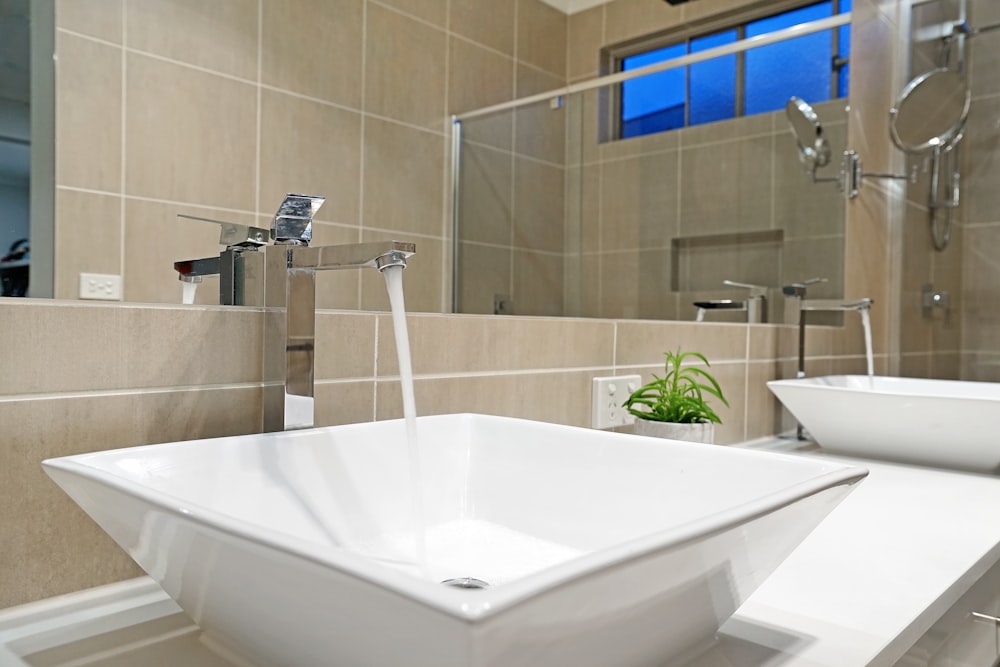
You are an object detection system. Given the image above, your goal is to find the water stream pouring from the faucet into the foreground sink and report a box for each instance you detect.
[382,266,427,573]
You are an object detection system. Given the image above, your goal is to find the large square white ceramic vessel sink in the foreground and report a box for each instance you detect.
[45,415,867,667]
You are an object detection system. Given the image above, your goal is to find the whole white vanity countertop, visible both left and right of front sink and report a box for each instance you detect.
[0,441,1000,667]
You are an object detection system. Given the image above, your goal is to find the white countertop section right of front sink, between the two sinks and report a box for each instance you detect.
[694,444,1000,667]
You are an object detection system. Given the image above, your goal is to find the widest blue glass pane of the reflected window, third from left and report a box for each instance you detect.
[744,2,833,116]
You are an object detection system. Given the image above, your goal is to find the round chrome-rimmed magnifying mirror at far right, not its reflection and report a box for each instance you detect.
[889,69,972,153]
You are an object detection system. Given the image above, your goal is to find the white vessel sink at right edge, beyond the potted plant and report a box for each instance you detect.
[767,375,1000,474]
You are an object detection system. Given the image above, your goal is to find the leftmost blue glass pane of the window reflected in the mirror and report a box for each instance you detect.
[621,44,687,139]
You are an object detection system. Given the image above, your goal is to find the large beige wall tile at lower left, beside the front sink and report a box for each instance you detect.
[0,386,259,608]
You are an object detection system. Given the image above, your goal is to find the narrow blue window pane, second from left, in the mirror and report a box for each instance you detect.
[688,30,738,125]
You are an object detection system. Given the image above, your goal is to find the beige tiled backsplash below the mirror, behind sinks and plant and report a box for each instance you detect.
[0,299,876,608]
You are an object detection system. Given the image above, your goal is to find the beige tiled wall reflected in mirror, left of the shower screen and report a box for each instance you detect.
[55,0,566,312]
